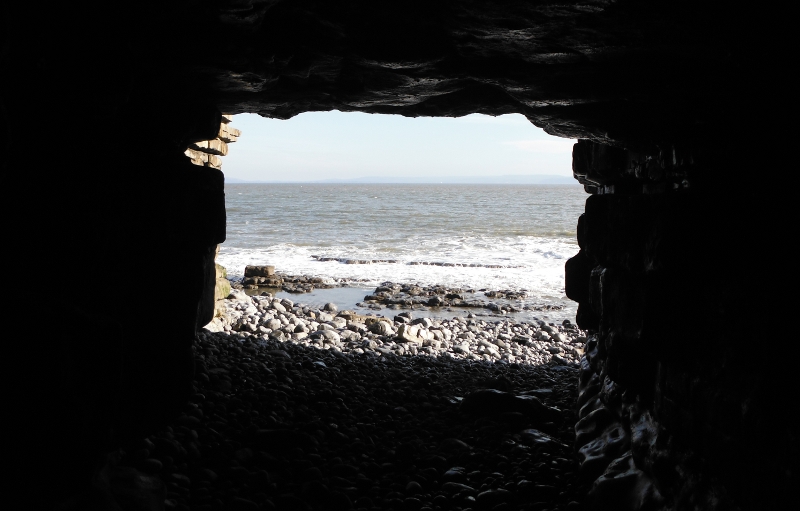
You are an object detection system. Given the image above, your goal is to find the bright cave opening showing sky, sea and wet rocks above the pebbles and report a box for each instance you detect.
[218,111,586,324]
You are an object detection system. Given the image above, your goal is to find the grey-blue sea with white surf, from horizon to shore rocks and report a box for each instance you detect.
[217,183,587,322]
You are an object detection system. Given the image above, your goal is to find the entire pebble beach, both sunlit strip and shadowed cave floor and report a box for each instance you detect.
[109,290,587,511]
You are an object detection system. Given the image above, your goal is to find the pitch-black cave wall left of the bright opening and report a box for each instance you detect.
[5,2,225,509]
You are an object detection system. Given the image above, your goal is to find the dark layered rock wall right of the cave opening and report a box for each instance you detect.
[566,141,798,509]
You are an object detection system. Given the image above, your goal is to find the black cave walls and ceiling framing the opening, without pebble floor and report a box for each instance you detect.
[7,0,798,510]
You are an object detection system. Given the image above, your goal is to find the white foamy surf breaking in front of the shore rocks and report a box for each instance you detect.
[218,236,578,304]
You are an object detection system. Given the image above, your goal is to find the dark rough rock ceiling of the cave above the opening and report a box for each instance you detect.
[3,0,769,153]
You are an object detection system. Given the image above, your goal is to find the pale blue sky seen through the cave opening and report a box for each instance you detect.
[222,111,575,182]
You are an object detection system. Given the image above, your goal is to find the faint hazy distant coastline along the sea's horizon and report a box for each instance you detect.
[225,174,580,186]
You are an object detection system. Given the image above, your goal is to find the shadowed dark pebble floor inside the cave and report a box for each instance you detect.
[120,333,587,511]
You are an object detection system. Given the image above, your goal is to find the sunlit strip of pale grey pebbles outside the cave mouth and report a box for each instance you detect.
[206,288,586,367]
